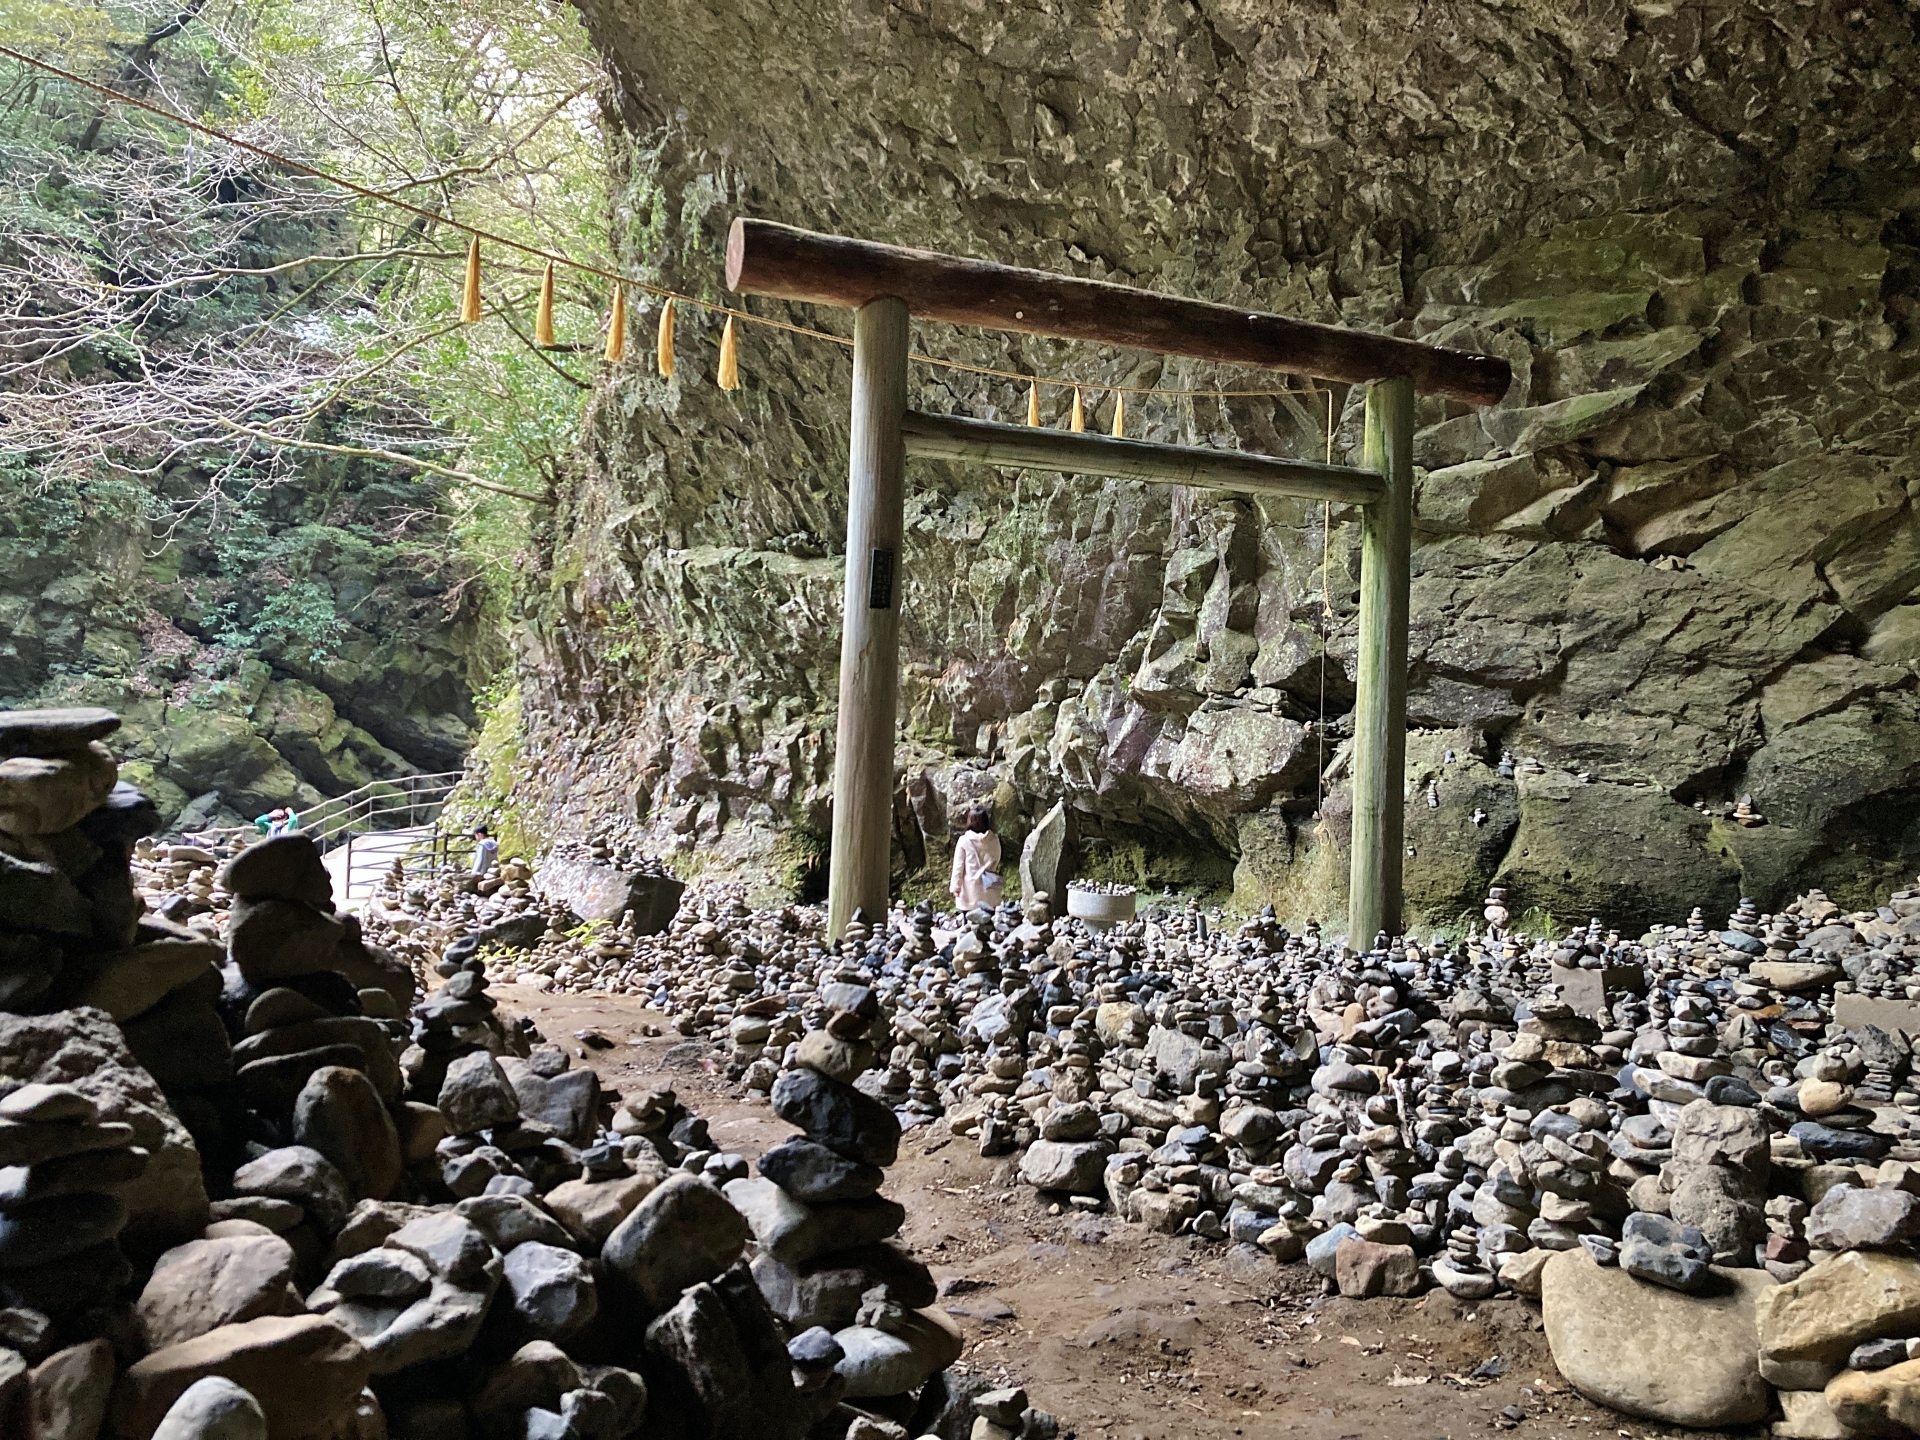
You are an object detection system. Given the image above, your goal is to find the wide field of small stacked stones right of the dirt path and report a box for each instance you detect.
[428,817,1920,1440]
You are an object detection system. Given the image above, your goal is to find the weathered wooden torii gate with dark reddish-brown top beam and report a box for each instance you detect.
[726,219,1513,948]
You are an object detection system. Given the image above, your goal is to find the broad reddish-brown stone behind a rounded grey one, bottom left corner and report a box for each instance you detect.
[109,1315,371,1440]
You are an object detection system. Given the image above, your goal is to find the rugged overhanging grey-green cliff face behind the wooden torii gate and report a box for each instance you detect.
[524,0,1920,924]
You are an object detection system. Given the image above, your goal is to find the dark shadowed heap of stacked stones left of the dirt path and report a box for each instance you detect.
[0,710,975,1440]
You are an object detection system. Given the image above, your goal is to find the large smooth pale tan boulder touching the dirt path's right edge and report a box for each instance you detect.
[1540,1248,1774,1430]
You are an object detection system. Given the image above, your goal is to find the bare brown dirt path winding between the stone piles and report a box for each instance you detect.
[492,985,1728,1440]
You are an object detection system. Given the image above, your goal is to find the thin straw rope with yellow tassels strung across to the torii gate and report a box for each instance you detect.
[0,44,1332,410]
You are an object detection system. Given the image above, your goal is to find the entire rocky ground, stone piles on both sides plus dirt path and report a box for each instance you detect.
[11,710,1920,1440]
